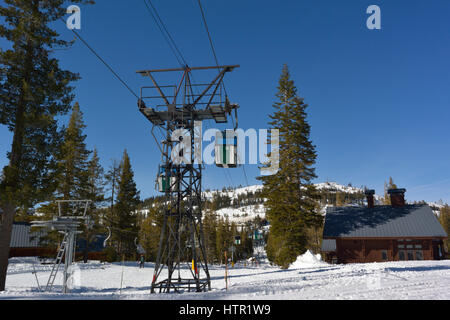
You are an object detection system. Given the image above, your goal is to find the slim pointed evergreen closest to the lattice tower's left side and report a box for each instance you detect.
[113,150,140,258]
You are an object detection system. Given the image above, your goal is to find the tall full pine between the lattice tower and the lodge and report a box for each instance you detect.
[259,65,322,268]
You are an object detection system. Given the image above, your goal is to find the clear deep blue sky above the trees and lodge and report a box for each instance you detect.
[0,0,450,202]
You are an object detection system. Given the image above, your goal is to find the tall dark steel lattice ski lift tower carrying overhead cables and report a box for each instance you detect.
[137,65,239,293]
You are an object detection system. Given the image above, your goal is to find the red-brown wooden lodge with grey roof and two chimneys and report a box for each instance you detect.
[322,189,448,263]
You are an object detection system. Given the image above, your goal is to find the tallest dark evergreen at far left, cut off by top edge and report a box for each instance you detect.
[0,0,93,291]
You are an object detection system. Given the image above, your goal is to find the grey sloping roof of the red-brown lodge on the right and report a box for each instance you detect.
[323,205,448,239]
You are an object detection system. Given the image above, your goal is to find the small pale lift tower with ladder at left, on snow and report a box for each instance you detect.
[31,200,91,293]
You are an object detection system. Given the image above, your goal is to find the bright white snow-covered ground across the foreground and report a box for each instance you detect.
[0,252,450,300]
